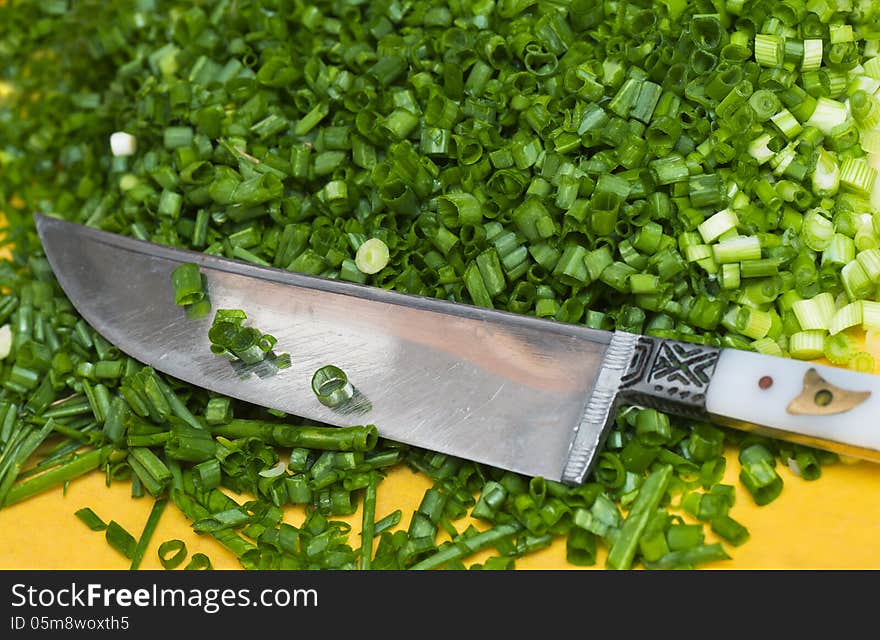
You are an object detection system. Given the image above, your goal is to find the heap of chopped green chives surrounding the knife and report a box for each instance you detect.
[0,0,880,569]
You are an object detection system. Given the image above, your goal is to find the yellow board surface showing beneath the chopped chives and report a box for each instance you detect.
[0,212,880,570]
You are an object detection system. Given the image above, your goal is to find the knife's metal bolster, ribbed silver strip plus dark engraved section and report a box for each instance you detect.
[562,331,721,484]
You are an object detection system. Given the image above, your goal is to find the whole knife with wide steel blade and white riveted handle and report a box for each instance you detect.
[34,214,880,484]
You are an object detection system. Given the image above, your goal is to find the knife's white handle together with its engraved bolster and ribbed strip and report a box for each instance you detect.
[564,332,880,483]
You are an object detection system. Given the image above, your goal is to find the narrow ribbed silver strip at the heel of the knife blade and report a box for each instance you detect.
[562,331,639,484]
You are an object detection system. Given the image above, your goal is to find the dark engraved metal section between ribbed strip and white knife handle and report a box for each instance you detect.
[620,336,721,417]
